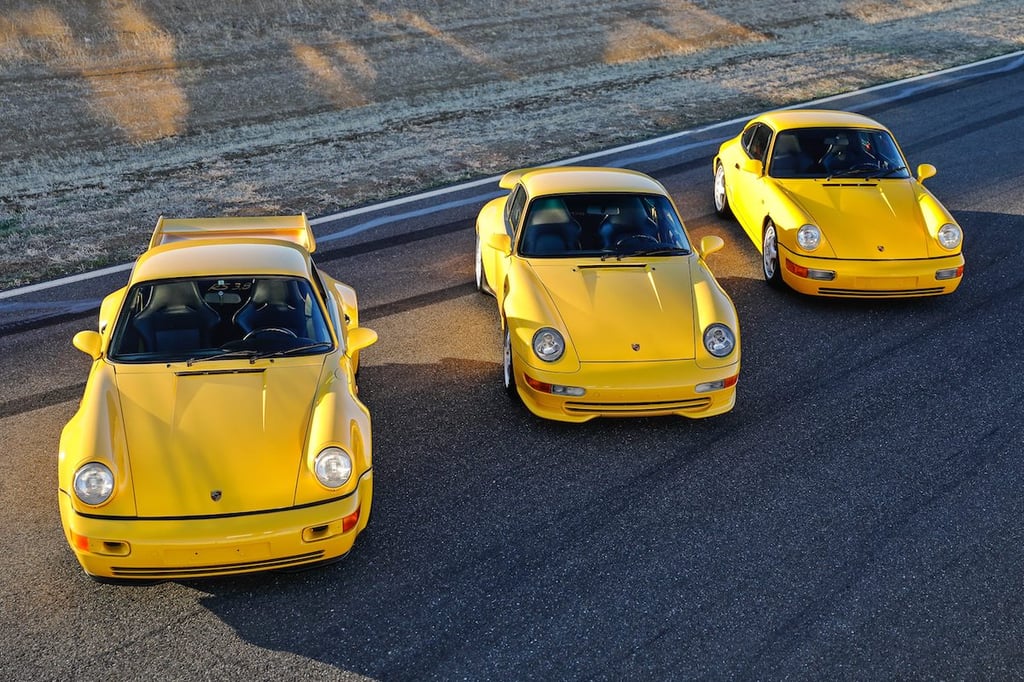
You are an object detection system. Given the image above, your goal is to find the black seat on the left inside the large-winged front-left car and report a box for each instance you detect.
[132,282,220,352]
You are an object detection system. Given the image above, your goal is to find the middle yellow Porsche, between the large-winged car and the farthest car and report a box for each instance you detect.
[476,167,739,422]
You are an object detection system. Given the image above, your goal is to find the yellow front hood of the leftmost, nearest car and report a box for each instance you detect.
[117,356,323,516]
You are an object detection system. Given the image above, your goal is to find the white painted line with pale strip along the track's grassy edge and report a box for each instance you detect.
[0,50,1024,300]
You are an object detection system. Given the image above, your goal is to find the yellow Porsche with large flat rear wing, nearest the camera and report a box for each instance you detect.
[57,215,377,581]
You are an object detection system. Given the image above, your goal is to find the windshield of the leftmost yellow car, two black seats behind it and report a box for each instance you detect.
[109,276,334,363]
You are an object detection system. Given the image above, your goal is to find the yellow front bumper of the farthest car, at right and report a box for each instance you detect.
[779,245,964,298]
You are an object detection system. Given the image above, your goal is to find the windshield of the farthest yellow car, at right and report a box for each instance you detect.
[768,128,910,178]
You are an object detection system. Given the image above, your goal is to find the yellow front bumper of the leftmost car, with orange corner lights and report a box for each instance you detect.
[57,470,373,581]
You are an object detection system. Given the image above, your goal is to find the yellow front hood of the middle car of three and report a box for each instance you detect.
[532,257,693,363]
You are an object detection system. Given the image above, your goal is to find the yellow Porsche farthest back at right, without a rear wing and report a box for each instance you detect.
[714,110,964,298]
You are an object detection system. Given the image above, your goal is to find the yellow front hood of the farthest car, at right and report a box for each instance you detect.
[779,178,932,260]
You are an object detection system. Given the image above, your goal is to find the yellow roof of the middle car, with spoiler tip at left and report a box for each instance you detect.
[501,166,669,197]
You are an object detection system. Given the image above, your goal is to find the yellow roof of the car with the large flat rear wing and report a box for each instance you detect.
[131,239,312,283]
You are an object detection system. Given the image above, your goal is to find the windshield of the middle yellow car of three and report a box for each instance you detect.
[519,194,690,258]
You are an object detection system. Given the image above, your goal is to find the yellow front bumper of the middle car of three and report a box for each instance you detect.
[513,350,739,422]
